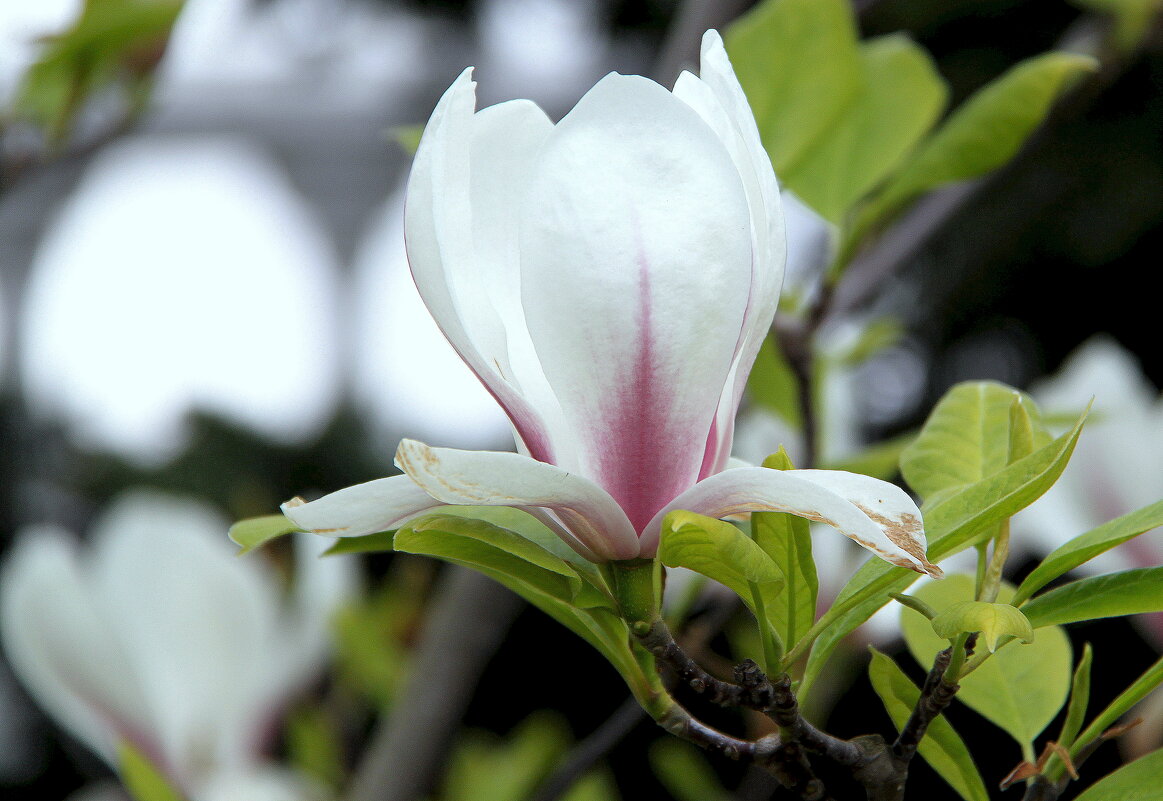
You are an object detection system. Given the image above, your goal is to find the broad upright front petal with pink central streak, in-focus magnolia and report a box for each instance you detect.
[521,74,751,529]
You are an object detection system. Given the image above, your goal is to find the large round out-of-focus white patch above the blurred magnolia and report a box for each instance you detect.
[16,137,340,462]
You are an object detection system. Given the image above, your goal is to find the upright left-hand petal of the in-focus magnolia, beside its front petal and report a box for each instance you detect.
[404,70,555,459]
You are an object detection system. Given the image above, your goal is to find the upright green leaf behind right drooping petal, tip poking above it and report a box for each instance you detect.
[751,448,820,643]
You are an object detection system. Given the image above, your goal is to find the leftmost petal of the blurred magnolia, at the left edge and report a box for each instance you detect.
[0,527,150,765]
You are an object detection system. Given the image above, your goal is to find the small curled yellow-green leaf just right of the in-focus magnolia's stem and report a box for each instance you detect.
[658,509,784,613]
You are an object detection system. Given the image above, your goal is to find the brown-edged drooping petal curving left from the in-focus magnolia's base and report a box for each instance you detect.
[395,439,638,560]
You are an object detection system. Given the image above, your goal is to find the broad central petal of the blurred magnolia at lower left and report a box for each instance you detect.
[91,493,280,787]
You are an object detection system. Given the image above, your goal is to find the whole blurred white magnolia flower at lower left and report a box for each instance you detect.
[0,494,355,801]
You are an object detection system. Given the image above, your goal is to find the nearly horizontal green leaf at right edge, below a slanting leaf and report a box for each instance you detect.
[1022,567,1163,628]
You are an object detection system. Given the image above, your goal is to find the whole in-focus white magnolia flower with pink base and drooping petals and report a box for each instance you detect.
[284,31,939,573]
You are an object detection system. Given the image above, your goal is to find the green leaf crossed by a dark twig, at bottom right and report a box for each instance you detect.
[869,646,990,801]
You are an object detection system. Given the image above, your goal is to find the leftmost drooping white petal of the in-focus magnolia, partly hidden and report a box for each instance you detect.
[281,475,443,537]
